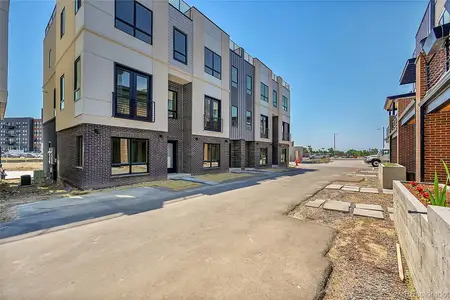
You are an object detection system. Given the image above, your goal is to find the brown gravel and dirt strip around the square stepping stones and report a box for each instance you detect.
[290,178,413,300]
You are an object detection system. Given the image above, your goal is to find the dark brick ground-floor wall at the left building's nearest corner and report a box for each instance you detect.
[57,124,167,188]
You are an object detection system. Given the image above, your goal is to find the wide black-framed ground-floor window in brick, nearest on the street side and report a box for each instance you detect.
[111,138,148,175]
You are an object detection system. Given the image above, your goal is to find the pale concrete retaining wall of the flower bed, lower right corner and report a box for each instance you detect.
[394,181,450,299]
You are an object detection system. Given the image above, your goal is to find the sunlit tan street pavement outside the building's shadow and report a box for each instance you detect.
[0,161,364,299]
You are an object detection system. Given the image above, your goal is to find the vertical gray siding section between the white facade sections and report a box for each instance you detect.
[230,50,255,141]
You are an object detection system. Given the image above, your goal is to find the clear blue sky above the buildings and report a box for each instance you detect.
[6,0,428,150]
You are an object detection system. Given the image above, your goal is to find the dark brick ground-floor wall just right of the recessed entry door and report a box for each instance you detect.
[191,135,230,175]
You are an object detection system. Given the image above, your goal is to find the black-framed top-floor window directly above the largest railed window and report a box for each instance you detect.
[115,0,153,45]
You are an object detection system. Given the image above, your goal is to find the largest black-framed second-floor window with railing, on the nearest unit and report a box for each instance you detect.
[114,65,154,122]
